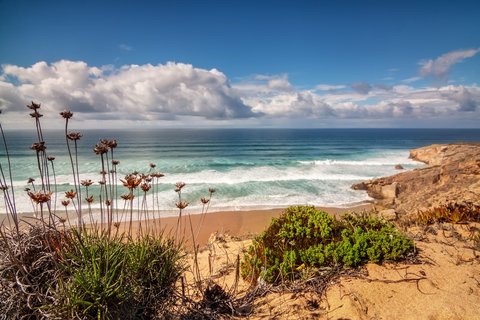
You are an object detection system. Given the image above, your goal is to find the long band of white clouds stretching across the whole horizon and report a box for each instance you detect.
[0,60,480,126]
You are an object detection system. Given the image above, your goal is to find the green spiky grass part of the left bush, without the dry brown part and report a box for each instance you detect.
[54,230,184,319]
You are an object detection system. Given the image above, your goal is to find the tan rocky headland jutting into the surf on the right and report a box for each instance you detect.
[352,143,480,215]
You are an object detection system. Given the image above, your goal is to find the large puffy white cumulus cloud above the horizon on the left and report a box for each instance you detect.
[0,60,256,120]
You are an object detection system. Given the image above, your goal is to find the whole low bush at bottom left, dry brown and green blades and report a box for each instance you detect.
[0,226,185,319]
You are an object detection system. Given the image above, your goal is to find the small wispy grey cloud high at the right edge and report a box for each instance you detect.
[419,49,480,80]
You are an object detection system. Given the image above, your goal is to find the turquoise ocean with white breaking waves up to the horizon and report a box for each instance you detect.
[0,129,480,215]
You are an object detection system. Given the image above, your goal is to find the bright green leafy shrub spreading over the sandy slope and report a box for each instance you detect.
[241,206,413,283]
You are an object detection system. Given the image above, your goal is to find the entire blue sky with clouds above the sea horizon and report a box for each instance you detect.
[0,0,480,129]
